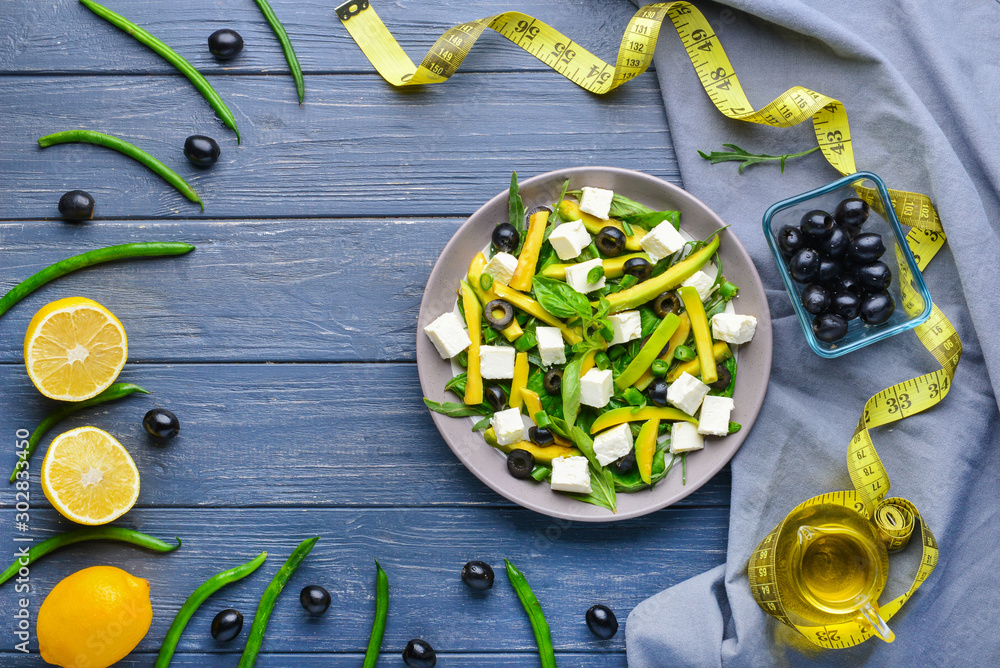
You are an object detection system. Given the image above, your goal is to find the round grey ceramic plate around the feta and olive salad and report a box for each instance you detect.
[417,167,771,522]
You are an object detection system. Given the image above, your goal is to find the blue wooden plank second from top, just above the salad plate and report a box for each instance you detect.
[0,73,678,220]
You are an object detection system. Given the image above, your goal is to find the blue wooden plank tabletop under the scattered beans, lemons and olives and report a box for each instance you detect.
[0,0,729,666]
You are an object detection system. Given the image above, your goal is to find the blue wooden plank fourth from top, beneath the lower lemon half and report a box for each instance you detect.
[0,364,730,508]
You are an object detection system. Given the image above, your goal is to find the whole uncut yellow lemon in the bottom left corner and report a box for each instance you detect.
[38,566,153,668]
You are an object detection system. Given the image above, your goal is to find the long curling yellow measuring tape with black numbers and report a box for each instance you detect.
[336,0,962,648]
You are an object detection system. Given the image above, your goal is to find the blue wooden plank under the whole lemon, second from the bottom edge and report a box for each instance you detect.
[0,506,728,658]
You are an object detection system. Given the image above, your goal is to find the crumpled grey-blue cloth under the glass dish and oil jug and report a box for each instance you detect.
[626,0,1000,668]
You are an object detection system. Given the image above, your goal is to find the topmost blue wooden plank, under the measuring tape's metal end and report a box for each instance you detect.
[0,0,644,74]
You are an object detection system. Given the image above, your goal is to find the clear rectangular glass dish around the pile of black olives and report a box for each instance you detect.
[764,172,931,358]
